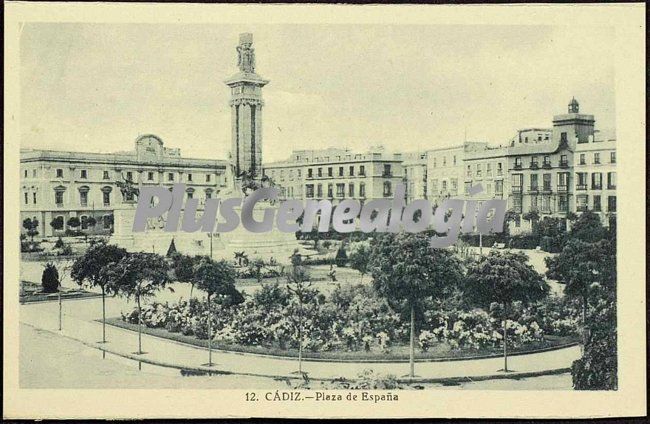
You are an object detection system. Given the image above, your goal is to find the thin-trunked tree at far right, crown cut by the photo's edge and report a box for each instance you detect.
[545,240,616,356]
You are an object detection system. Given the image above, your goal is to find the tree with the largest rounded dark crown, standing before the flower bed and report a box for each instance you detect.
[369,233,462,377]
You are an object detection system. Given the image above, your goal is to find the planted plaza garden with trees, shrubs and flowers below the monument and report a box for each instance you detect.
[22,212,617,389]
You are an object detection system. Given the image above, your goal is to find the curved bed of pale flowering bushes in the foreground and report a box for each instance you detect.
[113,284,577,359]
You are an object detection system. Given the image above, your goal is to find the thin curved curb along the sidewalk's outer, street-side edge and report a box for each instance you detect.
[21,322,571,384]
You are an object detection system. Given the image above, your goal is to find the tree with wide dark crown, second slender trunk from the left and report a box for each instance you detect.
[103,252,170,354]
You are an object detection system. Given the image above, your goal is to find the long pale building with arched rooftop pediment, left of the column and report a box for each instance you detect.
[20,134,233,237]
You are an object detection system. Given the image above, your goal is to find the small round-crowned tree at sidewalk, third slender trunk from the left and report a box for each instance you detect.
[194,260,239,367]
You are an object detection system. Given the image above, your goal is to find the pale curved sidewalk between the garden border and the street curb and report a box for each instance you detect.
[20,299,580,382]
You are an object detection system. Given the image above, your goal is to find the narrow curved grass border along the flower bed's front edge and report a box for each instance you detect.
[105,318,580,364]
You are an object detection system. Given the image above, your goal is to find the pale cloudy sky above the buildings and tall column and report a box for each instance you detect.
[20,23,615,162]
